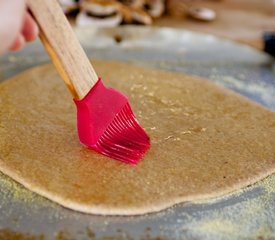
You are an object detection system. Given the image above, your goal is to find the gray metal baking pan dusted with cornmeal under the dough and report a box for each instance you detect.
[0,27,275,240]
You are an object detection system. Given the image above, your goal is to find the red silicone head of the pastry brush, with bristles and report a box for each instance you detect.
[75,79,150,164]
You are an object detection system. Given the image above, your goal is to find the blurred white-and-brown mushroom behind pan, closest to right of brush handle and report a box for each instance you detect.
[76,0,122,27]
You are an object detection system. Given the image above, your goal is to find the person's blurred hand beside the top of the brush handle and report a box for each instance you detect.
[0,0,38,53]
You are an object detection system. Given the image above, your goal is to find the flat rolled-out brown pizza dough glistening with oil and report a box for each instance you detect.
[0,61,275,215]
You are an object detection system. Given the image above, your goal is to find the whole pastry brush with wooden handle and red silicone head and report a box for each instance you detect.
[27,0,150,164]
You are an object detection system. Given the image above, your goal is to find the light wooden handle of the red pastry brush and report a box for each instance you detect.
[27,0,98,99]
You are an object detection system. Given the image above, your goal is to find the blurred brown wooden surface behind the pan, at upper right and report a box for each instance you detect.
[155,0,275,48]
